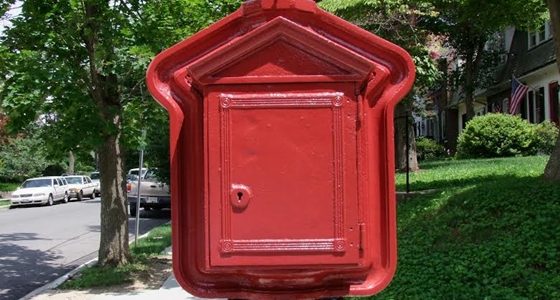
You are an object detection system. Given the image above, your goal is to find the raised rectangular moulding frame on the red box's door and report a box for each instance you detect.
[219,93,346,254]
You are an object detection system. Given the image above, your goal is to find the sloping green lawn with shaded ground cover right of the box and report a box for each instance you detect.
[376,156,560,299]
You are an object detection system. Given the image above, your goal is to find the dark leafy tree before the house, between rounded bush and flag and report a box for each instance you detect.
[422,0,544,120]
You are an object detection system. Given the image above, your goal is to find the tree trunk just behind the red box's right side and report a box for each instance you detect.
[395,102,419,172]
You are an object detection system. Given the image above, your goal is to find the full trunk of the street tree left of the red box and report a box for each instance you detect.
[82,1,130,266]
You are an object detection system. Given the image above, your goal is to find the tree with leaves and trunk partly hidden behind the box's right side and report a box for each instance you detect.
[321,0,440,171]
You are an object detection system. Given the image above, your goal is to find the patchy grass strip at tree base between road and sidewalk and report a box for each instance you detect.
[59,224,171,289]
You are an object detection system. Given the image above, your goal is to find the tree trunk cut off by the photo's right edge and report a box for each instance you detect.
[544,0,560,181]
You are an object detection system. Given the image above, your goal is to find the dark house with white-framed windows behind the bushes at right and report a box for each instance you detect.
[415,22,560,151]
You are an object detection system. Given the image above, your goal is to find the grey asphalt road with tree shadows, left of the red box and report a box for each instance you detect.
[0,198,169,300]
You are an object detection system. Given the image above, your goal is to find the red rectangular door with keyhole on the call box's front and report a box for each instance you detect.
[209,92,359,266]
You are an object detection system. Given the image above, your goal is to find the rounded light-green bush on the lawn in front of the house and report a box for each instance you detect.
[457,114,537,158]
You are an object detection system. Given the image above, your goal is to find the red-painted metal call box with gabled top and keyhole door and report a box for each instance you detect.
[147,0,415,299]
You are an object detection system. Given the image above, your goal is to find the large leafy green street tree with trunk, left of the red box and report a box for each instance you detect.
[0,0,238,266]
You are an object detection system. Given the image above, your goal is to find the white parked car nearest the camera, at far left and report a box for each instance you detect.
[10,176,68,206]
